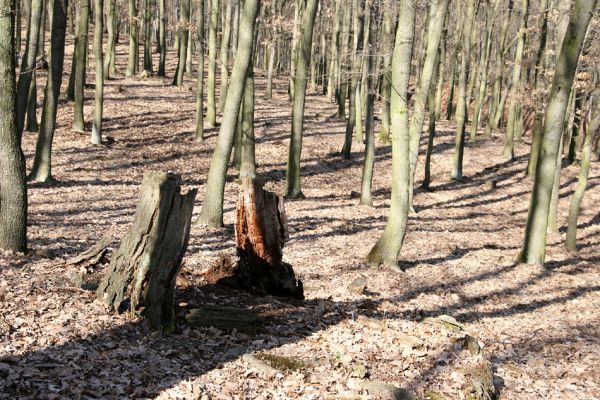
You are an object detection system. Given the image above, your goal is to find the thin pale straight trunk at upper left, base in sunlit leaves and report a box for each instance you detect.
[90,0,103,144]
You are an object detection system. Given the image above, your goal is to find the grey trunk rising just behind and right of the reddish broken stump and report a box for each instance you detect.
[285,0,319,198]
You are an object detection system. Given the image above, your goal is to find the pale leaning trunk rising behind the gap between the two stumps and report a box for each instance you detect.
[197,0,260,227]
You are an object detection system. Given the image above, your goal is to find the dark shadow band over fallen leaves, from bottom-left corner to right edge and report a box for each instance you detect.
[0,250,600,399]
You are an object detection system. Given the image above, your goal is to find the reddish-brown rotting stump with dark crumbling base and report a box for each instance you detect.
[206,178,304,299]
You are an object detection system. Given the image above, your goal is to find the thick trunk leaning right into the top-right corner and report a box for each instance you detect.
[519,0,598,264]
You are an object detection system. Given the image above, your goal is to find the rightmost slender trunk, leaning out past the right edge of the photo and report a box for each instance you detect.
[565,99,600,251]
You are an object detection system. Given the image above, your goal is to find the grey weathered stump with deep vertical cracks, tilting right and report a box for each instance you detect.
[96,172,197,332]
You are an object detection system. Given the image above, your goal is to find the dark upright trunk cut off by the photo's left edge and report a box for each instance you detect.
[0,0,27,252]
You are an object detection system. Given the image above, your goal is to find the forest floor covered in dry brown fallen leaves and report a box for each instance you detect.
[0,39,600,399]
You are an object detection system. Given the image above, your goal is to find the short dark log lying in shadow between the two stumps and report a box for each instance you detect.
[185,306,258,333]
